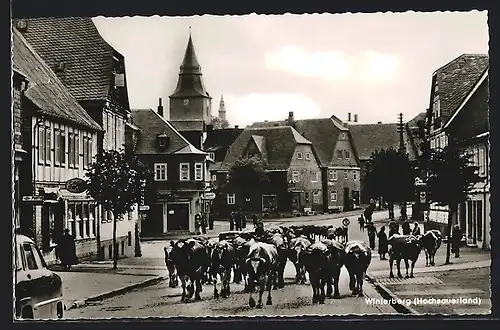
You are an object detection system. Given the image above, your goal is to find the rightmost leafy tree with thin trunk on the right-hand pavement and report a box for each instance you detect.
[427,142,483,264]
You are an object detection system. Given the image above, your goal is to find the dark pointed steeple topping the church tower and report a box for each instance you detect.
[170,27,210,98]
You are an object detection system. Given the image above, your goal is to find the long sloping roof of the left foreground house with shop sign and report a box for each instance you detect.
[12,29,102,131]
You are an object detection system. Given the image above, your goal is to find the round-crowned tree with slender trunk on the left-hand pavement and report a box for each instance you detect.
[85,150,152,269]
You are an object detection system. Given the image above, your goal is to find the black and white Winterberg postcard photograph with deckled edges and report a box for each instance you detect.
[11,10,492,321]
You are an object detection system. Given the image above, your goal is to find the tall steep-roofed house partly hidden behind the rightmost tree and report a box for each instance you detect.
[426,54,489,232]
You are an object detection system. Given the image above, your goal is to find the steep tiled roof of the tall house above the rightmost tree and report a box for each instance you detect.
[431,54,489,125]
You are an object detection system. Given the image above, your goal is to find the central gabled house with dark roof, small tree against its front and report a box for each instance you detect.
[214,126,323,217]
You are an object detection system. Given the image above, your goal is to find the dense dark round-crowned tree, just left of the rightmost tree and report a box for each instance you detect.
[364,148,415,219]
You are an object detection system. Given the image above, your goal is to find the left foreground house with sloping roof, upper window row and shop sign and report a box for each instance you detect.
[12,29,102,263]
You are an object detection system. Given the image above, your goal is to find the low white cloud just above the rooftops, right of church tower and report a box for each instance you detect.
[221,93,321,126]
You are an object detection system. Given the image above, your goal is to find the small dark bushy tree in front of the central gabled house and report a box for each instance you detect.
[223,156,269,211]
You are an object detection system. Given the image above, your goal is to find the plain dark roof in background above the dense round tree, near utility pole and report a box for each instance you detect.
[349,123,399,160]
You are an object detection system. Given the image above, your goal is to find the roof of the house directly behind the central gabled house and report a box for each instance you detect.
[251,117,348,166]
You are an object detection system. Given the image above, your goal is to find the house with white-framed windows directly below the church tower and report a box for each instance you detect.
[128,108,210,237]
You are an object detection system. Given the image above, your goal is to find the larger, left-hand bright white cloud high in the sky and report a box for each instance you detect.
[264,46,350,80]
